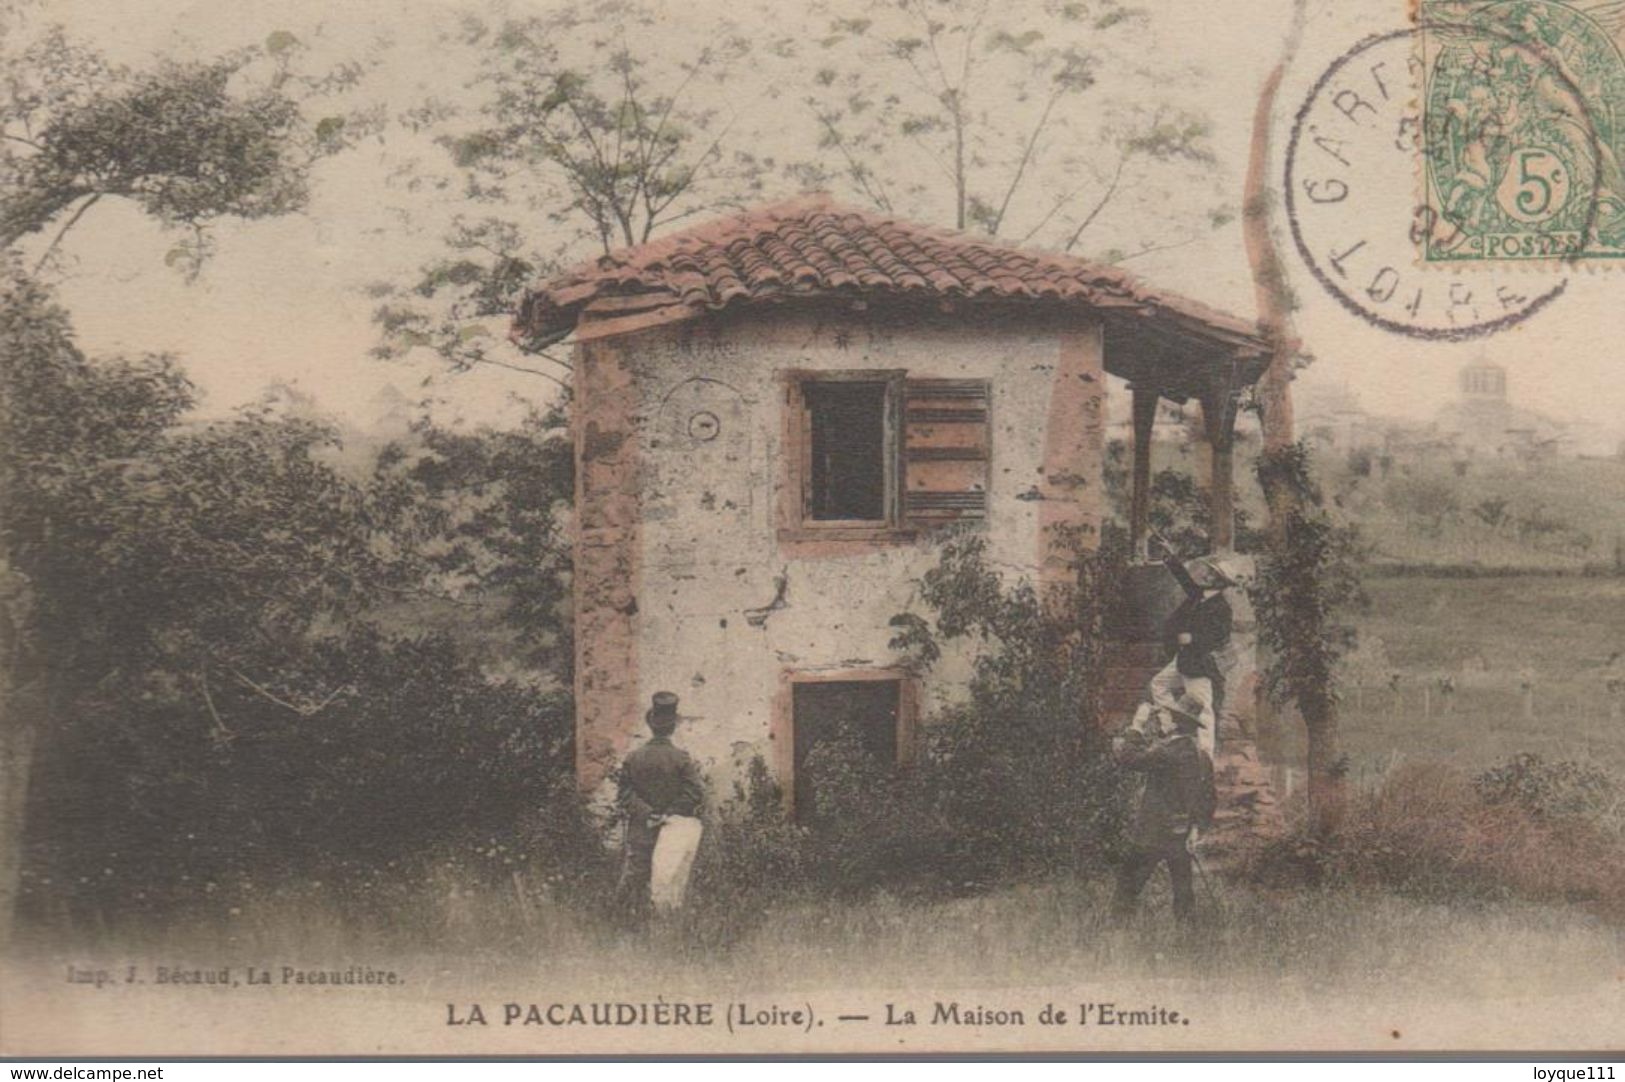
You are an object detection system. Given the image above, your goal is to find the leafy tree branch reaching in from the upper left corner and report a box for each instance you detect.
[0,16,369,271]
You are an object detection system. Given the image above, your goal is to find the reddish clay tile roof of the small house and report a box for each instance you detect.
[514,195,1264,357]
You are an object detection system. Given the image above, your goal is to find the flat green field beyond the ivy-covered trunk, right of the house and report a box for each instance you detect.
[1285,575,1625,777]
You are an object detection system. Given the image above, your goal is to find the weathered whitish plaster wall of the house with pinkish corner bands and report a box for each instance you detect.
[577,303,1105,791]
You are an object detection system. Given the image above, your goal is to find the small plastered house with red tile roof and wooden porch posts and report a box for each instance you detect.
[514,197,1264,812]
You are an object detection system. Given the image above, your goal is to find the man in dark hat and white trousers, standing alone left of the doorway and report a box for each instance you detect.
[616,692,705,918]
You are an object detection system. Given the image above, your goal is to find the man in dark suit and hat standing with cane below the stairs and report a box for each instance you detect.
[1112,695,1214,921]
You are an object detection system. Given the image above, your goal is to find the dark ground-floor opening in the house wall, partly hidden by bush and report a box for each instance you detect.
[791,681,902,822]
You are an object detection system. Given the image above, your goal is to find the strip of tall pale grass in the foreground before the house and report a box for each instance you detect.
[15,877,1625,996]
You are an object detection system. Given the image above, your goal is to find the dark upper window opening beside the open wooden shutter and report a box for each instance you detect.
[801,380,889,522]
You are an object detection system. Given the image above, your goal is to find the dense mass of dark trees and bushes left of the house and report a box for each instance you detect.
[0,261,590,915]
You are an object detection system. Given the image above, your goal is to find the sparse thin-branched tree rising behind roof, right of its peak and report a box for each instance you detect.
[798,0,1229,260]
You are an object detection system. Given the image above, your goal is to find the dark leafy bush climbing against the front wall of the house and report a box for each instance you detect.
[697,535,1125,920]
